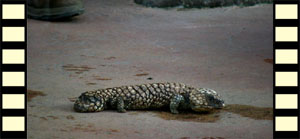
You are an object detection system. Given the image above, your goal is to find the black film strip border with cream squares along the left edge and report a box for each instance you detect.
[0,0,27,138]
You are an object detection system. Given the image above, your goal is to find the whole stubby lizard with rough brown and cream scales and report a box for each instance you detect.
[74,83,225,114]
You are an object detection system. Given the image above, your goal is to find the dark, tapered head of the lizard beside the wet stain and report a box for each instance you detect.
[189,88,225,112]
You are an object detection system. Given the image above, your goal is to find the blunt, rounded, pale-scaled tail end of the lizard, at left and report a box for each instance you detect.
[74,92,104,112]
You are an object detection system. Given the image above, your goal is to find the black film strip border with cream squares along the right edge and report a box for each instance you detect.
[273,0,300,139]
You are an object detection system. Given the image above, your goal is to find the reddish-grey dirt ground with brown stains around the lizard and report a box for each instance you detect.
[28,0,273,139]
